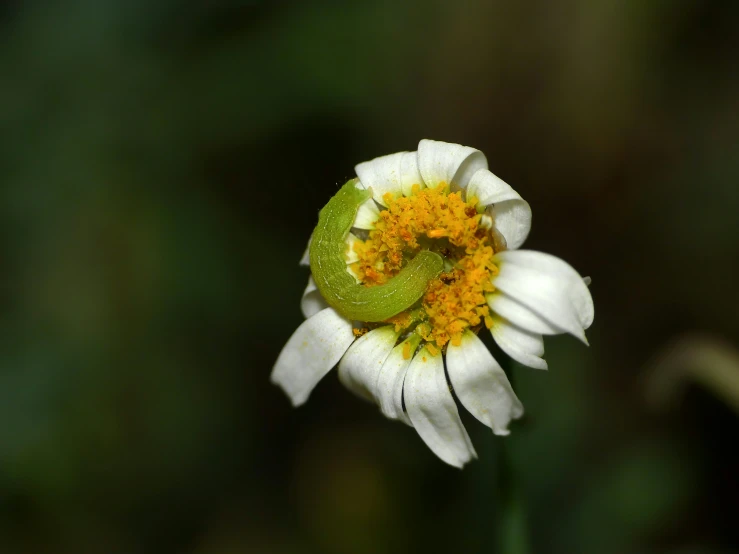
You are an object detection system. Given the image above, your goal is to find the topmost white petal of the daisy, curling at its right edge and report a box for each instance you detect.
[418,139,488,188]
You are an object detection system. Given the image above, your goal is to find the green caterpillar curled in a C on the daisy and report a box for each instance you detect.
[310,179,444,322]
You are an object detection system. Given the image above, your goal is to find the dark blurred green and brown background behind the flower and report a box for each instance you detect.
[0,0,739,554]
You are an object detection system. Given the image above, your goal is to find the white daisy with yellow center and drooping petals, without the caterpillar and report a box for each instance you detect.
[272,140,593,467]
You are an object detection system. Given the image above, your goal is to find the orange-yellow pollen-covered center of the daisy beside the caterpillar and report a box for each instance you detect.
[350,183,501,355]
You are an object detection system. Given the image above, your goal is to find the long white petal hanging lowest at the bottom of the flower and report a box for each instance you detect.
[403,348,477,467]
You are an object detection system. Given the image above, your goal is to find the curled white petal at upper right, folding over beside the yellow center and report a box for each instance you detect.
[467,169,531,250]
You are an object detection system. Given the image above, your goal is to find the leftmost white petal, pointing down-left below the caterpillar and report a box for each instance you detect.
[271,308,354,406]
